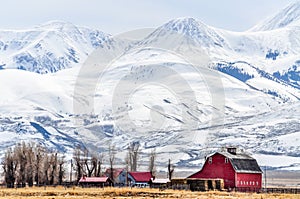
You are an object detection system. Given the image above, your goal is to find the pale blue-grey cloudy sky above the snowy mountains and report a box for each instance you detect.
[0,0,295,34]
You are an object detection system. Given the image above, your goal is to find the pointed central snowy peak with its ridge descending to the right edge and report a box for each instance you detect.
[133,18,300,101]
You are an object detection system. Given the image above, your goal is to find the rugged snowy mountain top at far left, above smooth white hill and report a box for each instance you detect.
[0,21,123,74]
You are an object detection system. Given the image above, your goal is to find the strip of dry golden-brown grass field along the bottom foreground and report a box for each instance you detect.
[0,187,300,199]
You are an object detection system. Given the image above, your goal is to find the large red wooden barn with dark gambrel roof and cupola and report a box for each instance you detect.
[189,147,262,191]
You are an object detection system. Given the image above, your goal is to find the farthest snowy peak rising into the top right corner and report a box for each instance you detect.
[250,1,300,31]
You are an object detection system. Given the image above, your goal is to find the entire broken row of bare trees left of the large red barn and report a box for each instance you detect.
[2,142,174,188]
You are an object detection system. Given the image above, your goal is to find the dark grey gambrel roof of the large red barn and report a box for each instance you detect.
[214,151,262,173]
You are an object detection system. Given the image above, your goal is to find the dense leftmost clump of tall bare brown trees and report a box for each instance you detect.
[2,142,65,188]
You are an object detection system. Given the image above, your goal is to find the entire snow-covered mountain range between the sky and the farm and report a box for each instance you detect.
[0,2,300,169]
